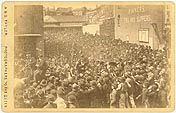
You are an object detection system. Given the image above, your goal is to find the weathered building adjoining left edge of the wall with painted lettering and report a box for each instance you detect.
[85,5,115,35]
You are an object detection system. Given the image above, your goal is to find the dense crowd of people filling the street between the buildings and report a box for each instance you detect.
[14,31,170,109]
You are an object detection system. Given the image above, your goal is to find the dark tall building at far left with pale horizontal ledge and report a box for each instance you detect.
[14,5,44,57]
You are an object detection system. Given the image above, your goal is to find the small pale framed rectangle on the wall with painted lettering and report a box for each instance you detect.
[139,29,149,42]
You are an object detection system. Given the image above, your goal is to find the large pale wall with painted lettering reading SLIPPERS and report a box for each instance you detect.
[114,5,170,49]
